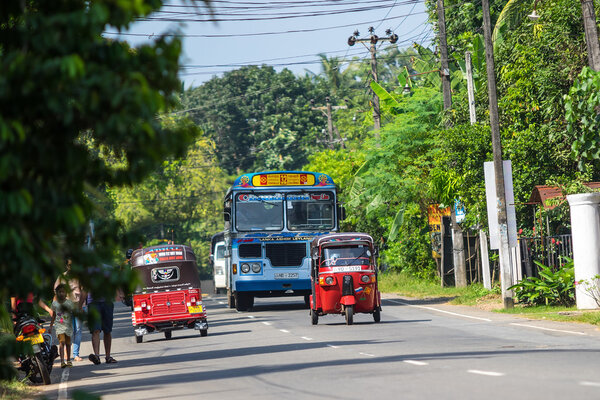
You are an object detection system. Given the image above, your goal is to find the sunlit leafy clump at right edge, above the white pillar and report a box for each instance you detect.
[565,67,600,169]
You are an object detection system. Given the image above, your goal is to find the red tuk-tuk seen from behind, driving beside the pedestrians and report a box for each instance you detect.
[130,245,208,343]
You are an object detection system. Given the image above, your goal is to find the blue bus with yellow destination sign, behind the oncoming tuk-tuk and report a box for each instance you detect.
[223,171,344,311]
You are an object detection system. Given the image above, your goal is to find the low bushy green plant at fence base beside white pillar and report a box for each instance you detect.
[509,260,575,306]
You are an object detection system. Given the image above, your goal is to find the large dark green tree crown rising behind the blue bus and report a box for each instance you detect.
[182,66,329,174]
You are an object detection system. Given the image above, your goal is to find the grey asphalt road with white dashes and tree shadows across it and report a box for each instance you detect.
[43,297,600,400]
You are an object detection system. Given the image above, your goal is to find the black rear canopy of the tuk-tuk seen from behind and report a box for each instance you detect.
[131,244,200,292]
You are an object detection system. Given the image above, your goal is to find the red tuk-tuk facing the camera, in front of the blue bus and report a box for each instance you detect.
[310,233,381,325]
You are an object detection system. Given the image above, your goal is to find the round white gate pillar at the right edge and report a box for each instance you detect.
[567,193,600,309]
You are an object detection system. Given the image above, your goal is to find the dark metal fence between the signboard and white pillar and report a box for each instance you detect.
[519,235,573,277]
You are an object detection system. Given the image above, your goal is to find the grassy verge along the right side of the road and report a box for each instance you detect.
[379,272,600,326]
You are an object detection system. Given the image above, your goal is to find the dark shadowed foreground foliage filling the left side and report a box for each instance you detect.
[0,0,204,380]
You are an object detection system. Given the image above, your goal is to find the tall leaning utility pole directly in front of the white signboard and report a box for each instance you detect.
[481,0,515,309]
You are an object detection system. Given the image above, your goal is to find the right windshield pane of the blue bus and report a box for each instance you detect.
[286,192,335,231]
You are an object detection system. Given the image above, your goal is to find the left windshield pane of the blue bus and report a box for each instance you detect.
[235,193,283,231]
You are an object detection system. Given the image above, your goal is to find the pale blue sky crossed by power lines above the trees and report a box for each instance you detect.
[105,0,434,88]
